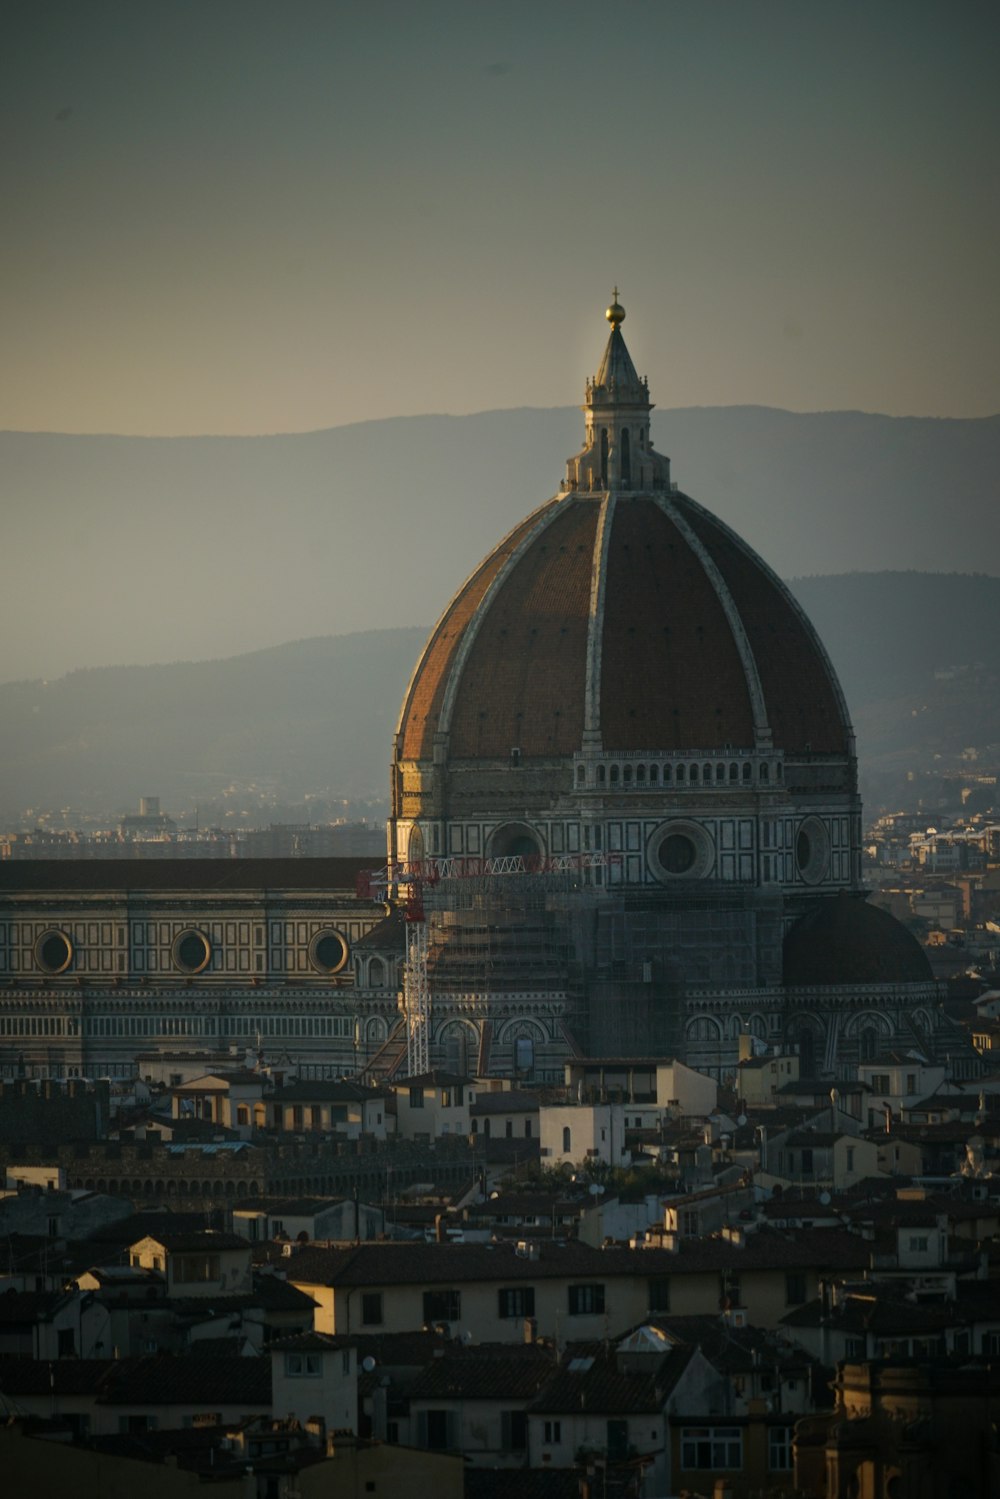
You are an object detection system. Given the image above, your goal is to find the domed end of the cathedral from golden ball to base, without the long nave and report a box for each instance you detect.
[390,298,937,1075]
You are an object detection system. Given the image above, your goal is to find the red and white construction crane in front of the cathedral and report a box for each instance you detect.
[358,853,621,1078]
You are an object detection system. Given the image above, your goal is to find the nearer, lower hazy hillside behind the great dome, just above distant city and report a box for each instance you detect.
[0,573,1000,815]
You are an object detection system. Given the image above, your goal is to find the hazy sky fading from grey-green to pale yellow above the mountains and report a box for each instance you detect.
[0,0,1000,435]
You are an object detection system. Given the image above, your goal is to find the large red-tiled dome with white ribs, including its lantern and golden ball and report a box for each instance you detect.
[397,298,852,763]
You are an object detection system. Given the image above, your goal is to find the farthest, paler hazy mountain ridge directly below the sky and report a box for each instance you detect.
[0,406,1000,682]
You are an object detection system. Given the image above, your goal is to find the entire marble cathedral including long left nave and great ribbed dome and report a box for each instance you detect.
[0,295,940,1081]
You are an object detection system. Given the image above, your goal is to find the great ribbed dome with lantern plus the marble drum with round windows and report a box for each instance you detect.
[388,297,861,893]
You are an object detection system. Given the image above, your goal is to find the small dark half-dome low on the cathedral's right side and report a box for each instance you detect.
[784,892,934,988]
